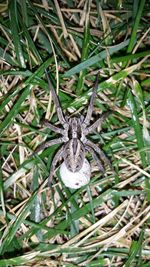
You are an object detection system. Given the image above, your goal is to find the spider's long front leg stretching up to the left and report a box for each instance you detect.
[45,70,66,124]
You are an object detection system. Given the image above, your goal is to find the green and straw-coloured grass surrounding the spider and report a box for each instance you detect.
[0,0,150,267]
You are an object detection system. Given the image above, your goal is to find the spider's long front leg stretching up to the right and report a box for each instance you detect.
[84,72,99,125]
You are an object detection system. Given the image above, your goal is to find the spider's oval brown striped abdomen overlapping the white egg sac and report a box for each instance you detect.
[63,138,85,172]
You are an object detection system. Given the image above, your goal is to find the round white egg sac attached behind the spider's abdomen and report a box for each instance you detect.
[60,159,91,189]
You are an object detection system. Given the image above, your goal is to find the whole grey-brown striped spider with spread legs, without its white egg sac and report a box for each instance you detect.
[33,70,113,184]
